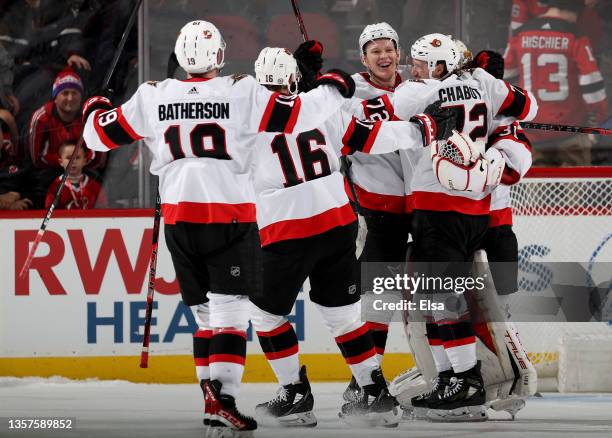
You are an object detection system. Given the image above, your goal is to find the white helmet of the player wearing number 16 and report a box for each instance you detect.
[255,47,301,95]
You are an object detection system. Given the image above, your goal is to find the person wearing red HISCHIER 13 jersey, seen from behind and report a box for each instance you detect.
[505,0,608,166]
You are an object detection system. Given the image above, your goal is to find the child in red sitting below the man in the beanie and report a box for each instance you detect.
[45,140,107,210]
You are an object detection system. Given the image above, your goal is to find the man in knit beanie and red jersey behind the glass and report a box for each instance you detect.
[28,68,105,184]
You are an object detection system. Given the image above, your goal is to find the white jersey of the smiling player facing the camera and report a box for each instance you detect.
[344,73,407,214]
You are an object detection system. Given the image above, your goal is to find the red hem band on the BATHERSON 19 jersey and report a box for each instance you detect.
[162,202,256,225]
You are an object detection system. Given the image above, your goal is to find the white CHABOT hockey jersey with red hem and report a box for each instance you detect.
[343,69,537,215]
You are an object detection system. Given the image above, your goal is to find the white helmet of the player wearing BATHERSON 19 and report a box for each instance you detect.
[174,20,225,73]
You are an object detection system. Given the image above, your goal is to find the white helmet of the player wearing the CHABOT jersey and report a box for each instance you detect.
[410,33,461,77]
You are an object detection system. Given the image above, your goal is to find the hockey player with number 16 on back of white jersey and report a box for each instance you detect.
[251,48,399,427]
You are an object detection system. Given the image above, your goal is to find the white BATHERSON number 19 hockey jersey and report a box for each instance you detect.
[83,76,344,224]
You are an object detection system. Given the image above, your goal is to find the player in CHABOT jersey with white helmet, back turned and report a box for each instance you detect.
[344,34,537,421]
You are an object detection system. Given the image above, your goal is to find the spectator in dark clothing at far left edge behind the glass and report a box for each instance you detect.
[0,110,43,210]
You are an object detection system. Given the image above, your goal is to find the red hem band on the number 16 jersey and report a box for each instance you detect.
[259,203,357,246]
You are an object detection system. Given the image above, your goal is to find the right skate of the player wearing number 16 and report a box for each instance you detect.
[338,368,400,427]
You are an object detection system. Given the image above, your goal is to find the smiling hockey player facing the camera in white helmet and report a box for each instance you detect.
[344,22,412,401]
